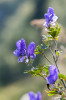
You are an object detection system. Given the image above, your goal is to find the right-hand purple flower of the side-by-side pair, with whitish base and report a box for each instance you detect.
[26,42,36,63]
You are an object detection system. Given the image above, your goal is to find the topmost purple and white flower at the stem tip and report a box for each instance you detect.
[43,7,58,28]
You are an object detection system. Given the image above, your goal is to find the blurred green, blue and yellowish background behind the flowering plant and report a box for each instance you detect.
[0,0,66,100]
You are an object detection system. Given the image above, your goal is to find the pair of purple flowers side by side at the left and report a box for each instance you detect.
[13,39,36,63]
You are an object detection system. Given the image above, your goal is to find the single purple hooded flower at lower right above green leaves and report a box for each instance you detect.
[46,65,58,84]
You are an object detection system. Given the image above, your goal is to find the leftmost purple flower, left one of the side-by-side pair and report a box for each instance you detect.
[13,39,26,62]
